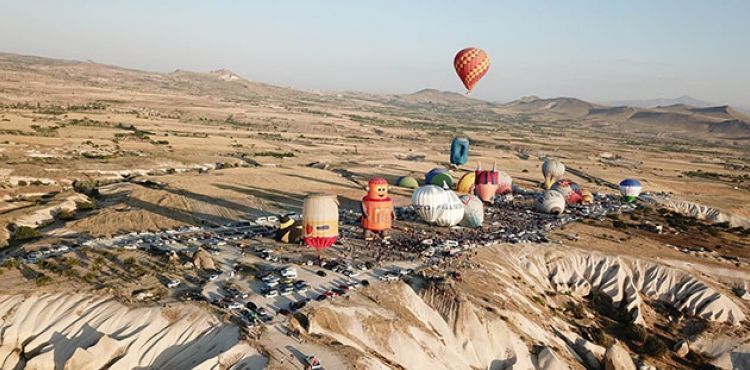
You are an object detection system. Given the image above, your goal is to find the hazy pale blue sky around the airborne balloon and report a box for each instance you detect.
[0,0,750,107]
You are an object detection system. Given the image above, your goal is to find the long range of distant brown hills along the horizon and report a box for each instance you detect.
[0,53,750,139]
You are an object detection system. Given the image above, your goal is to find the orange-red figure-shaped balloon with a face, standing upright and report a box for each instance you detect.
[362,177,396,240]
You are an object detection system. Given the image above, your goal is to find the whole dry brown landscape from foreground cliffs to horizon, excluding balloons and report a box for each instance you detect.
[0,54,750,370]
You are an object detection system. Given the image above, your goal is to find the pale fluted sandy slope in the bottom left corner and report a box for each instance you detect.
[0,294,265,369]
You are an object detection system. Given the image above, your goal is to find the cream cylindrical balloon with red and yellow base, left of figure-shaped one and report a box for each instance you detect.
[302,194,339,251]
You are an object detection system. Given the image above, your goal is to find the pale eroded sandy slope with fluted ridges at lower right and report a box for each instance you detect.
[309,245,747,369]
